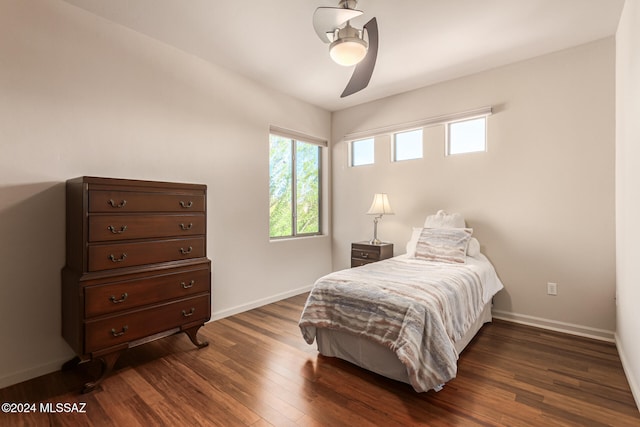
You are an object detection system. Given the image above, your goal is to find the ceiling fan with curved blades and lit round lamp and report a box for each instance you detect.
[313,0,378,98]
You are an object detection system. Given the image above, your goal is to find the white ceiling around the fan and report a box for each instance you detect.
[66,0,624,111]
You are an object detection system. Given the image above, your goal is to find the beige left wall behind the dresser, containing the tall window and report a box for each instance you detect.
[0,0,331,387]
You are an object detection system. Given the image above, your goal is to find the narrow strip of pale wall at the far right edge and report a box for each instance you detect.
[616,1,640,407]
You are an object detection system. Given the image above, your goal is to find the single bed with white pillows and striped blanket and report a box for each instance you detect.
[299,211,503,392]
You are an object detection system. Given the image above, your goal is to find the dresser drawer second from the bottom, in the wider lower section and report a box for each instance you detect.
[84,267,211,317]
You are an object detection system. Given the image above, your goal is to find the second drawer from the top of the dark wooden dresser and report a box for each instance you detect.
[89,214,205,242]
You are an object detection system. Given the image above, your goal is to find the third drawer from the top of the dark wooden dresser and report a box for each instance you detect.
[88,237,205,271]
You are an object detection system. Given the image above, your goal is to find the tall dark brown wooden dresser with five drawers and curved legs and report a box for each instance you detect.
[62,177,211,392]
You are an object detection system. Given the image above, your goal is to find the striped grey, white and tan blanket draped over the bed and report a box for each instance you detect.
[299,258,483,392]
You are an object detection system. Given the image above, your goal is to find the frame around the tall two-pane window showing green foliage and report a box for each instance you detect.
[268,132,328,240]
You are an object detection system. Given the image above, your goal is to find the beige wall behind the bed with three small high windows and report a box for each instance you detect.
[332,38,615,339]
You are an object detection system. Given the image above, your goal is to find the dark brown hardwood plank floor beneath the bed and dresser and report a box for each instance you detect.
[0,295,640,427]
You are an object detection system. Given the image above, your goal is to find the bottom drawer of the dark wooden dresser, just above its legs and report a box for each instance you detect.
[85,294,211,353]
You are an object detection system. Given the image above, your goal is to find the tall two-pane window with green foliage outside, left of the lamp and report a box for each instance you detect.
[269,134,321,238]
